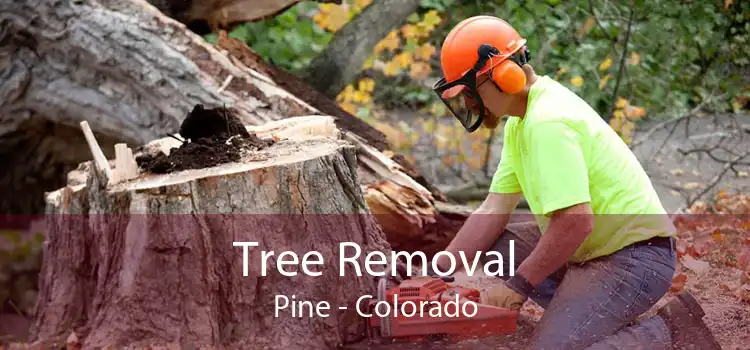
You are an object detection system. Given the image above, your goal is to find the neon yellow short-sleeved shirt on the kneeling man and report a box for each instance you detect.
[490,76,675,262]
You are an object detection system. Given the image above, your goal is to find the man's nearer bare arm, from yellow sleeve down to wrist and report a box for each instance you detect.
[516,203,594,287]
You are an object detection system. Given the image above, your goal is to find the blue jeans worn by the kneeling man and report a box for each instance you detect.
[484,222,677,349]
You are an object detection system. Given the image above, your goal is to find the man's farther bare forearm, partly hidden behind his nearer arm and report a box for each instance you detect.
[436,192,521,272]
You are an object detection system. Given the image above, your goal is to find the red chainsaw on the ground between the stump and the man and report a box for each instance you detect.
[367,277,518,342]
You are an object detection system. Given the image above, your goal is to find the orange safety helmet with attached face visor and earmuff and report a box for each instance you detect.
[433,16,529,132]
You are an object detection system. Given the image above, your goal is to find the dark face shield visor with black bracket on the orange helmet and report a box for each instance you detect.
[432,45,532,132]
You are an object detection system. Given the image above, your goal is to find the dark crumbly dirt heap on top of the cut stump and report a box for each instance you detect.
[136,104,274,174]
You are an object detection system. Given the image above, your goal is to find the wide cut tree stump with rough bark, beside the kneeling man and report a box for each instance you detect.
[31,114,390,349]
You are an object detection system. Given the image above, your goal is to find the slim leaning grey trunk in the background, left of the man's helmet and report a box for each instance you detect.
[305,0,426,98]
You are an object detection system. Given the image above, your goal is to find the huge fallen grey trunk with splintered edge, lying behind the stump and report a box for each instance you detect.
[0,0,468,258]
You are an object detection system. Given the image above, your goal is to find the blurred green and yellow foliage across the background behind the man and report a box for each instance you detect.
[207,0,750,151]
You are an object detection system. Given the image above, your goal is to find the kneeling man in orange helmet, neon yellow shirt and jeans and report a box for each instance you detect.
[432,16,720,349]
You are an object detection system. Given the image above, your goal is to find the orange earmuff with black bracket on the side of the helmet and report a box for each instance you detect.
[479,44,529,94]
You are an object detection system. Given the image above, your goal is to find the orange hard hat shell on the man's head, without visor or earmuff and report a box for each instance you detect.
[440,16,526,83]
